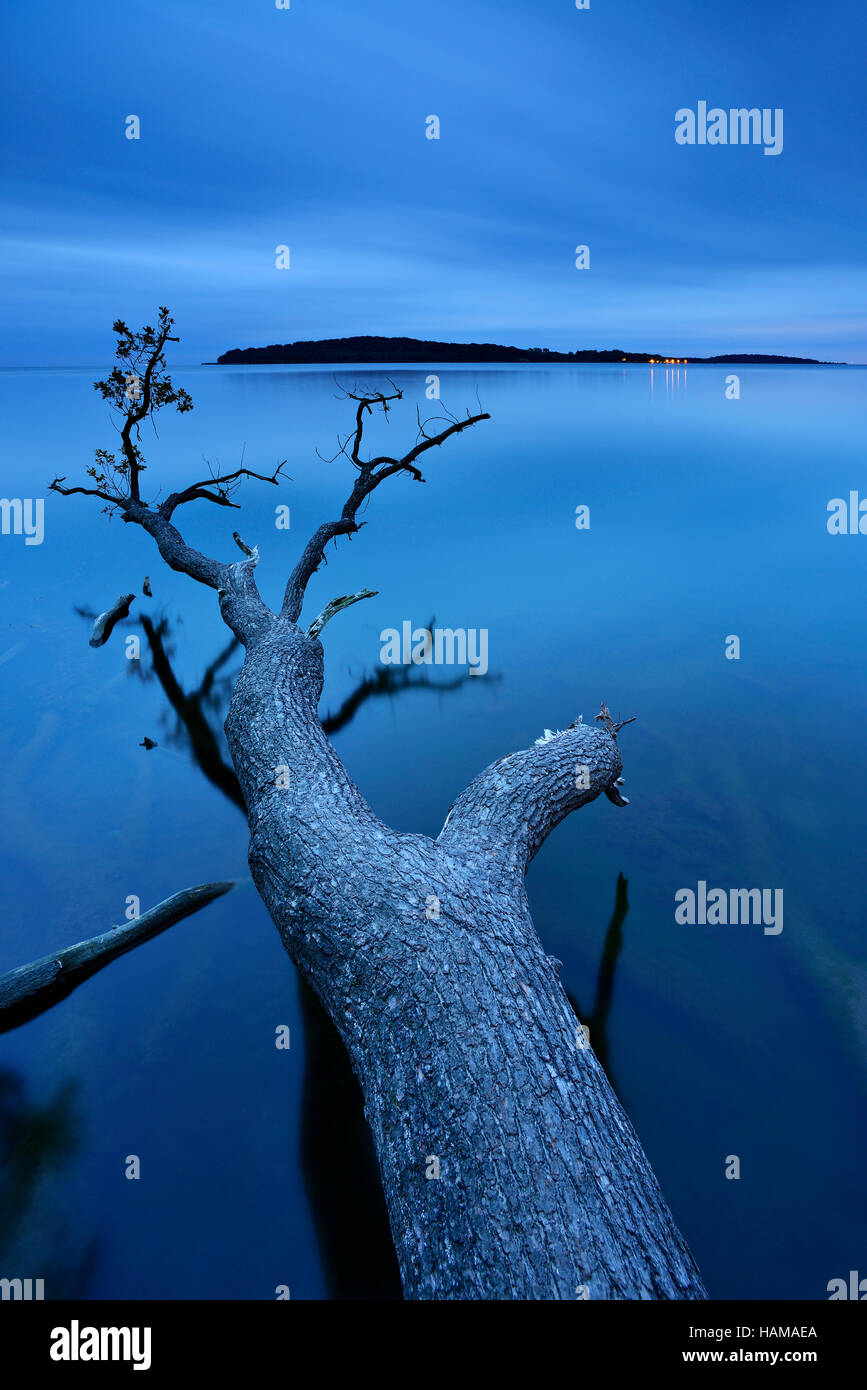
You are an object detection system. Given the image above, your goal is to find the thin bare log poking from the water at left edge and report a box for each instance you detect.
[0,880,235,1033]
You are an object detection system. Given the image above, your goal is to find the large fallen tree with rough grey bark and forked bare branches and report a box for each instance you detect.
[51,310,706,1300]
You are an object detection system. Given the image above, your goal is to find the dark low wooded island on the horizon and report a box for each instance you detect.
[201,330,848,367]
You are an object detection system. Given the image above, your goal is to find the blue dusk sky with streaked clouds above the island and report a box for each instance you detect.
[0,0,867,367]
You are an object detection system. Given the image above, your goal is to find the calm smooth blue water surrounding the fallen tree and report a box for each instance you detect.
[0,364,867,1298]
